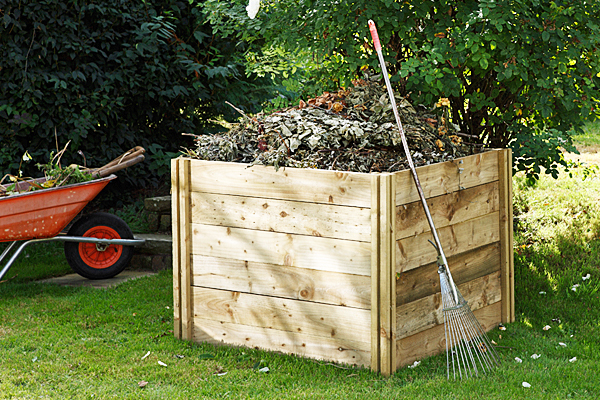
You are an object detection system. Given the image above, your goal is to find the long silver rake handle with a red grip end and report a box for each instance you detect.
[369,20,458,303]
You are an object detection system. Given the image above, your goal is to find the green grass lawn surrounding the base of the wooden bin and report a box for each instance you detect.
[0,150,600,399]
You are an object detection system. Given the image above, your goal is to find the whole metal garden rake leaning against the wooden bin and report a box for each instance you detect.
[369,20,498,379]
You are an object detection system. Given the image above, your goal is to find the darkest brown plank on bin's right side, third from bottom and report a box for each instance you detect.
[396,242,500,307]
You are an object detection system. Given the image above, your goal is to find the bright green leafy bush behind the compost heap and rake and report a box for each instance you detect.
[206,0,600,175]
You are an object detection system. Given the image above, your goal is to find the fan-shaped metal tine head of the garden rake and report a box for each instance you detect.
[438,265,499,379]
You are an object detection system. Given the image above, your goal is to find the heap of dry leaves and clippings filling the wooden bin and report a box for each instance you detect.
[184,78,480,172]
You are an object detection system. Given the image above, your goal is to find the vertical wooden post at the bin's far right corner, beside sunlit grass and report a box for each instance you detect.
[498,149,515,323]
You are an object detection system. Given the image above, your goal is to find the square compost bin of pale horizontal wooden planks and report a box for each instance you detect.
[171,150,515,375]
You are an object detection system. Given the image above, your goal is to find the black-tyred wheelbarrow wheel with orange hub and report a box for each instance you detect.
[65,212,133,279]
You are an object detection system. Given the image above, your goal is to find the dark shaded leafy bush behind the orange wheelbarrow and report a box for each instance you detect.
[0,0,271,194]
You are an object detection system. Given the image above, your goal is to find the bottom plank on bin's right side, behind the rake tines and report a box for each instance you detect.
[396,302,502,368]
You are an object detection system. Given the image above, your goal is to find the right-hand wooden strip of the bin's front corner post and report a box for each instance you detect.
[379,174,396,376]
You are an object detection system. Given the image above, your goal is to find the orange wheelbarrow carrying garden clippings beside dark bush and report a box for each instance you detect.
[0,147,144,280]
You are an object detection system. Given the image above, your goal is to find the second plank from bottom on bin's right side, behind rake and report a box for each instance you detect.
[396,271,502,338]
